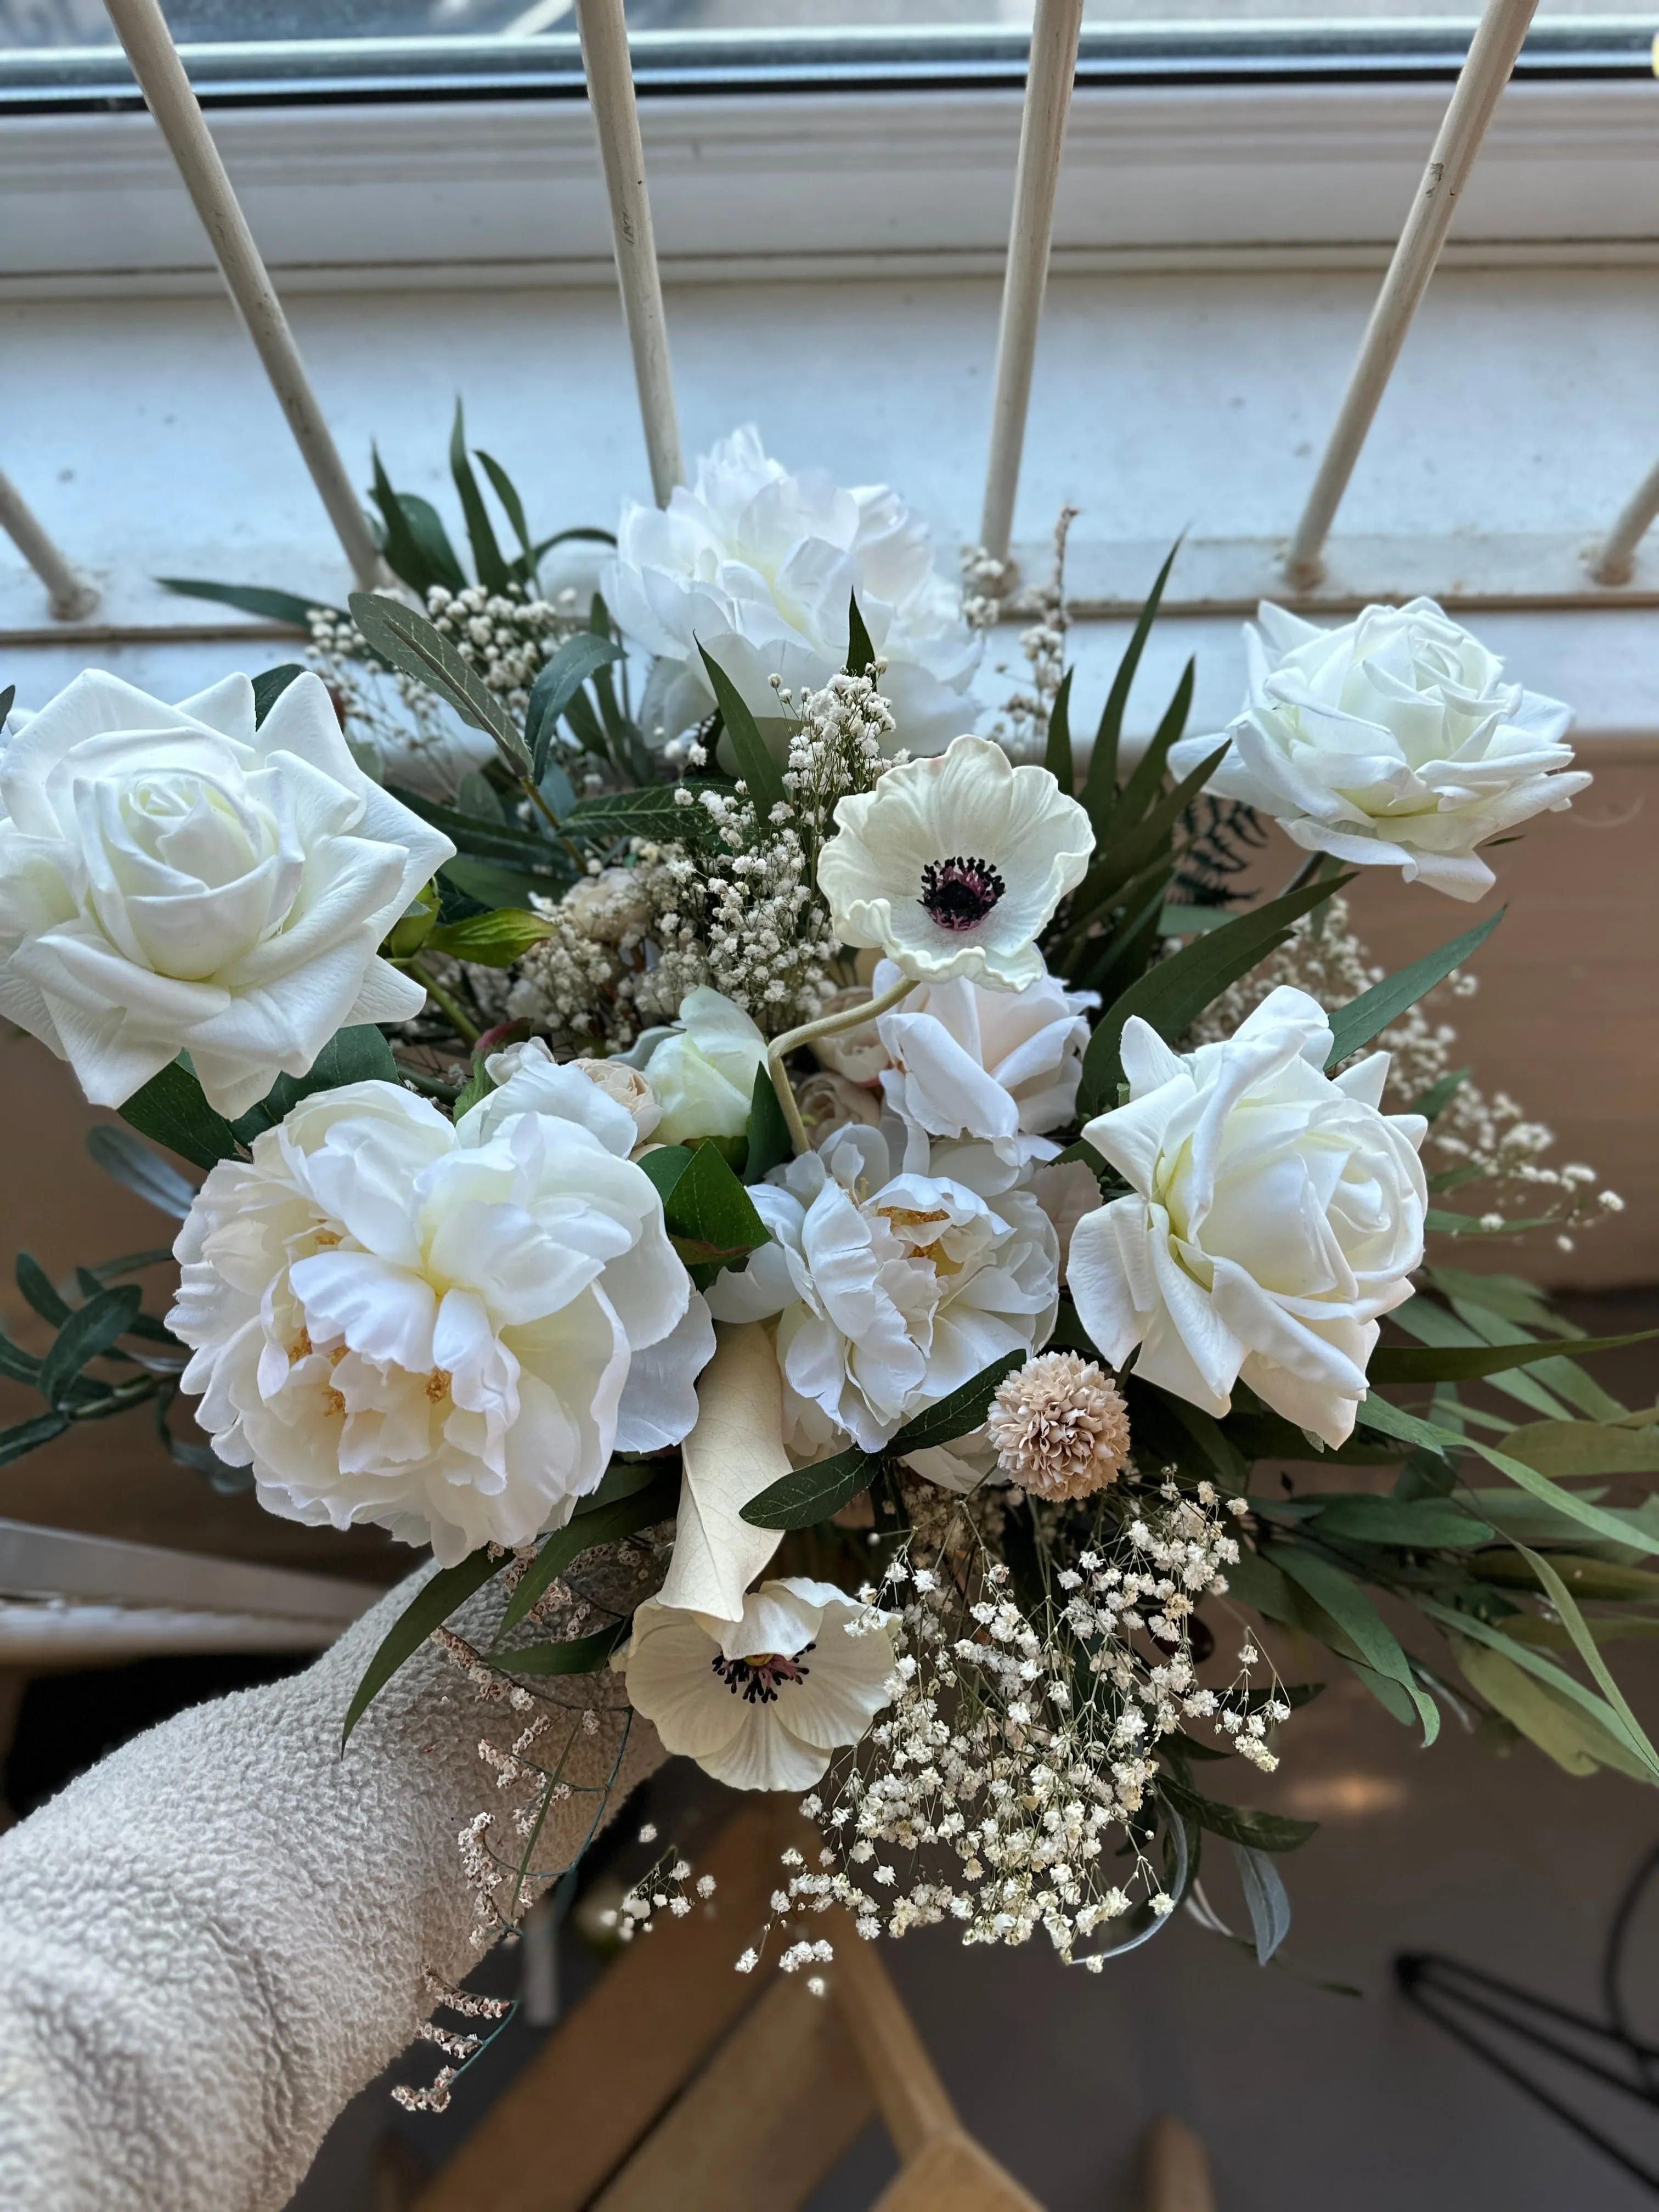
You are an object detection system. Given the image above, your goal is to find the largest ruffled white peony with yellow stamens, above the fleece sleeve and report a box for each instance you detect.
[168,1057,714,1566]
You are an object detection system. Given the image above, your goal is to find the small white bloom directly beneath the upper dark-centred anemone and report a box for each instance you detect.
[872,960,1099,1168]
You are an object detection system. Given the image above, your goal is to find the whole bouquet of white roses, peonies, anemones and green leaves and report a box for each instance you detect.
[0,422,1659,2026]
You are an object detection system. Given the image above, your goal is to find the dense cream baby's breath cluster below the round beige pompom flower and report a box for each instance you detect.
[774,1480,1290,1964]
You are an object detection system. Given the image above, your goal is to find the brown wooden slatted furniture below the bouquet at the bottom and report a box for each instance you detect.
[411,1798,1042,2212]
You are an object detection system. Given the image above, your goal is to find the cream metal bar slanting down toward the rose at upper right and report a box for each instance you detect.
[1285,0,1537,586]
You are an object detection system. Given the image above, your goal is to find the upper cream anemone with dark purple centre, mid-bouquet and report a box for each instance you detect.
[819,737,1095,991]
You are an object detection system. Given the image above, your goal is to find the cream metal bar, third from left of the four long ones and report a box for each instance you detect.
[980,0,1084,562]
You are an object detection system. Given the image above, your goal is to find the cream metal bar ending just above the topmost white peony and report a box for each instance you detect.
[575,0,686,506]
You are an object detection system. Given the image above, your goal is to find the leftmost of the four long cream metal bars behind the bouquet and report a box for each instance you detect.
[106,0,392,591]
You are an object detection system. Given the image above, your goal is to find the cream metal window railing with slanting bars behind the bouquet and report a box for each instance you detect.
[0,0,1659,619]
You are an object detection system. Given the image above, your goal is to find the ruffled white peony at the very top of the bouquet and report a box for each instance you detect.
[602,425,982,752]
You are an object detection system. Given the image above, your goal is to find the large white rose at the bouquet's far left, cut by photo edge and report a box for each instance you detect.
[0,670,456,1117]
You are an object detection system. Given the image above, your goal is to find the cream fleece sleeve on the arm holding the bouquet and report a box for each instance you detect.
[0,1577,664,2212]
